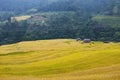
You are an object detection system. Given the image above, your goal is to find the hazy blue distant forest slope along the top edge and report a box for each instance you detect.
[0,0,120,15]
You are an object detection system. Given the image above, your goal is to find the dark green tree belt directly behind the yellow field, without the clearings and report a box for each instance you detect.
[0,12,120,44]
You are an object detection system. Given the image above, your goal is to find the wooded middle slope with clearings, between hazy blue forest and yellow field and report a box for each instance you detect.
[0,11,120,44]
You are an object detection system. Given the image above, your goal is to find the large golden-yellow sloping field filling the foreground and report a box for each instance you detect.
[0,39,120,80]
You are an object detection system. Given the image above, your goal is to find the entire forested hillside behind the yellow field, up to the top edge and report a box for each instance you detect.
[0,0,120,44]
